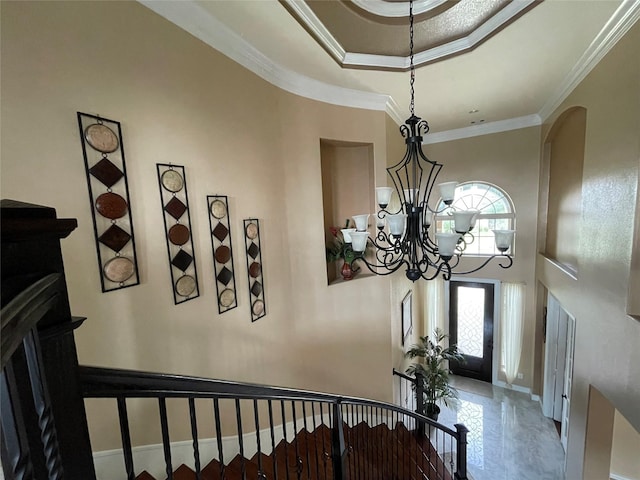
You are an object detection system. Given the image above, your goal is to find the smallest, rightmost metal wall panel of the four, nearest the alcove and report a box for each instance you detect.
[244,218,267,322]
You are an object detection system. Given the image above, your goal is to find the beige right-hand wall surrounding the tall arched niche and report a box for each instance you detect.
[537,24,640,478]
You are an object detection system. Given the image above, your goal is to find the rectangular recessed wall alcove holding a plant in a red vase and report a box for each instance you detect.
[320,139,375,285]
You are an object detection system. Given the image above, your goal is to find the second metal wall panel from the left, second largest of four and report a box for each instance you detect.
[156,163,200,305]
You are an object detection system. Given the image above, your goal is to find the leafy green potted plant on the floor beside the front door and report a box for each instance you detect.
[405,328,465,420]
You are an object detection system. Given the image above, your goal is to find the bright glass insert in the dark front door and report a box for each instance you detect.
[458,287,484,358]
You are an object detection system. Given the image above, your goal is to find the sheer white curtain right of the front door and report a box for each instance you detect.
[500,283,525,385]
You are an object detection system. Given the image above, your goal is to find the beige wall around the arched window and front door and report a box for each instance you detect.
[424,127,540,388]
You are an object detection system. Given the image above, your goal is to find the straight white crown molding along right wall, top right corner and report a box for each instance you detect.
[538,0,640,121]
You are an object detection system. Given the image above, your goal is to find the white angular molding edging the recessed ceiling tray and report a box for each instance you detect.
[282,0,537,70]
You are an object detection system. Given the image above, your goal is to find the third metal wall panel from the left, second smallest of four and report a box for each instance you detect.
[207,195,238,313]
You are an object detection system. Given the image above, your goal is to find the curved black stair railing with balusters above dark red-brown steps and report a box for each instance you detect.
[79,366,466,480]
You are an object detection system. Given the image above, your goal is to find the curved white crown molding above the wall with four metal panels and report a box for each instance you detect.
[138,0,390,113]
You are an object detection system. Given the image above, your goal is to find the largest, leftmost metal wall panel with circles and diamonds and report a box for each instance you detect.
[78,112,140,292]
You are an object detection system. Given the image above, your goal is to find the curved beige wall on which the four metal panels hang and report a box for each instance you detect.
[0,2,391,450]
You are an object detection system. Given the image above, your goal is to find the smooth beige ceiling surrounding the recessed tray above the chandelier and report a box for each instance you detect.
[176,0,640,132]
